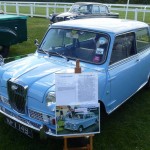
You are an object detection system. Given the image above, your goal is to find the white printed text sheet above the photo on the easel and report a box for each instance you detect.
[55,73,98,105]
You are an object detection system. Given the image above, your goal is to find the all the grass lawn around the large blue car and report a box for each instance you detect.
[0,14,150,150]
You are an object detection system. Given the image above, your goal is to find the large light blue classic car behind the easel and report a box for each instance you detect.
[0,18,150,136]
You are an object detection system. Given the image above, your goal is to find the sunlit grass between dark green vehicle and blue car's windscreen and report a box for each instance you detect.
[9,17,50,57]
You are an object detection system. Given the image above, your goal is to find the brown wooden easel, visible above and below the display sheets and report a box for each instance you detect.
[64,60,94,150]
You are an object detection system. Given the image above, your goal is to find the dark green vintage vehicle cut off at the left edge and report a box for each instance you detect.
[0,14,27,57]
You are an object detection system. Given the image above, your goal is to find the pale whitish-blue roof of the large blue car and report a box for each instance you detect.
[52,18,148,34]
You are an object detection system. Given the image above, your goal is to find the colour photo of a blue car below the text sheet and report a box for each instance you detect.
[56,104,100,136]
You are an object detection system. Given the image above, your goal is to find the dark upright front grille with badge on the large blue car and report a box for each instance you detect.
[7,80,27,114]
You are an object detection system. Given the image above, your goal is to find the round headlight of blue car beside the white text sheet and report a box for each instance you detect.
[46,92,56,111]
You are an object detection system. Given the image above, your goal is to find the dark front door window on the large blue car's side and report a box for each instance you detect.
[110,33,136,64]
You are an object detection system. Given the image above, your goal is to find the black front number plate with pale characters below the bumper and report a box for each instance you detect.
[5,118,33,137]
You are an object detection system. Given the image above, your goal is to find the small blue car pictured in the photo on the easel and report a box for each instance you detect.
[64,112,99,132]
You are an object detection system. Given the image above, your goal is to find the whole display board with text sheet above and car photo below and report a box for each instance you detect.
[55,73,100,136]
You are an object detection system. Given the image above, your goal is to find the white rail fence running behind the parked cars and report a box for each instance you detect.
[0,1,150,21]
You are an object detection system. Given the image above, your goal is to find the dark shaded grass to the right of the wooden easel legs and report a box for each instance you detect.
[94,89,150,150]
